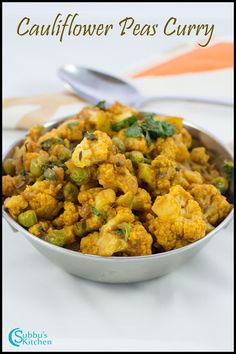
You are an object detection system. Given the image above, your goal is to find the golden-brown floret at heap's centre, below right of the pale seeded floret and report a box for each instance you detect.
[98,163,138,194]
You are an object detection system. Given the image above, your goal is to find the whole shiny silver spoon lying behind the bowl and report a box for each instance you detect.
[58,64,233,108]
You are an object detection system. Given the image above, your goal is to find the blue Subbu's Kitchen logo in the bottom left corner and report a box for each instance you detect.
[8,328,52,347]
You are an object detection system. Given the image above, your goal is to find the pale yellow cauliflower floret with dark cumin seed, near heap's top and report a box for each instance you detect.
[72,131,112,168]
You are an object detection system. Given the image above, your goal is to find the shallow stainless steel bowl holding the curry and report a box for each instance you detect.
[3,117,233,283]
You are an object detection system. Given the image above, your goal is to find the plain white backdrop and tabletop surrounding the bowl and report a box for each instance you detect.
[3,3,233,351]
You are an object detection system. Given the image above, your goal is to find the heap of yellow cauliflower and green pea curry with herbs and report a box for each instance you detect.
[3,101,233,256]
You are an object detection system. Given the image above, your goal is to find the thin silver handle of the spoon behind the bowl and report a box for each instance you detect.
[136,96,234,108]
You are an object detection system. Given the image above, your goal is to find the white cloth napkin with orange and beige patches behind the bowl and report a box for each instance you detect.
[3,42,233,129]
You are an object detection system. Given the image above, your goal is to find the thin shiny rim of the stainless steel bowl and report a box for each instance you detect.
[2,115,234,262]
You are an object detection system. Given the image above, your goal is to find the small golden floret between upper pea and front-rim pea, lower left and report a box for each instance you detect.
[52,202,79,229]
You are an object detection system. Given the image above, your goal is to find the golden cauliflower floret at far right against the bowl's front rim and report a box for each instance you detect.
[190,184,232,226]
